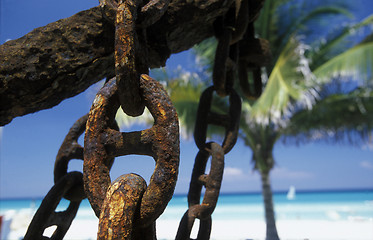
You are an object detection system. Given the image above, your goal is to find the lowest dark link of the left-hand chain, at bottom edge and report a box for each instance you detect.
[24,172,83,240]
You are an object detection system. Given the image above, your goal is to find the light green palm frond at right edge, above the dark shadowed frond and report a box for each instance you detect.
[314,35,373,82]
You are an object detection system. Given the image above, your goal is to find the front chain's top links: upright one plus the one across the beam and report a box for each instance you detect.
[100,0,169,117]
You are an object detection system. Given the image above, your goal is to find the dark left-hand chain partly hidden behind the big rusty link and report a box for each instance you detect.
[24,114,88,240]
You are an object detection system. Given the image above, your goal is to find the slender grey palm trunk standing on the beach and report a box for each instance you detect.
[259,171,280,240]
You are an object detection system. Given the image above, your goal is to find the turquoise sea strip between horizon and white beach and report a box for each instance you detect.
[0,189,373,221]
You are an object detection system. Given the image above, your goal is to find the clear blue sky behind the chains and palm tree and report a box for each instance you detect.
[0,0,373,198]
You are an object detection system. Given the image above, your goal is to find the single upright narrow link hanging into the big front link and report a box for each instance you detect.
[114,0,148,117]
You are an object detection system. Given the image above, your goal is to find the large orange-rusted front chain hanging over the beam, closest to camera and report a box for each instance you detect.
[84,0,179,240]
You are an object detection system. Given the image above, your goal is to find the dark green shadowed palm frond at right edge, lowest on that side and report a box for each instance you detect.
[284,88,373,142]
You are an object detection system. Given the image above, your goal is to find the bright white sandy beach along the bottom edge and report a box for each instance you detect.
[2,212,373,240]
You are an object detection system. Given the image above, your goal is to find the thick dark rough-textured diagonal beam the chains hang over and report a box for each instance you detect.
[0,0,233,126]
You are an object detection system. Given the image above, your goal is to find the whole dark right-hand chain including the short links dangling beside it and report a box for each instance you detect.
[176,0,269,237]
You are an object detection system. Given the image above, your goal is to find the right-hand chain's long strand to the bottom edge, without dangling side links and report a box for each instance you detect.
[176,3,247,240]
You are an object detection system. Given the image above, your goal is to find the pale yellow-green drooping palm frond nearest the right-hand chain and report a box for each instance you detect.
[251,38,315,122]
